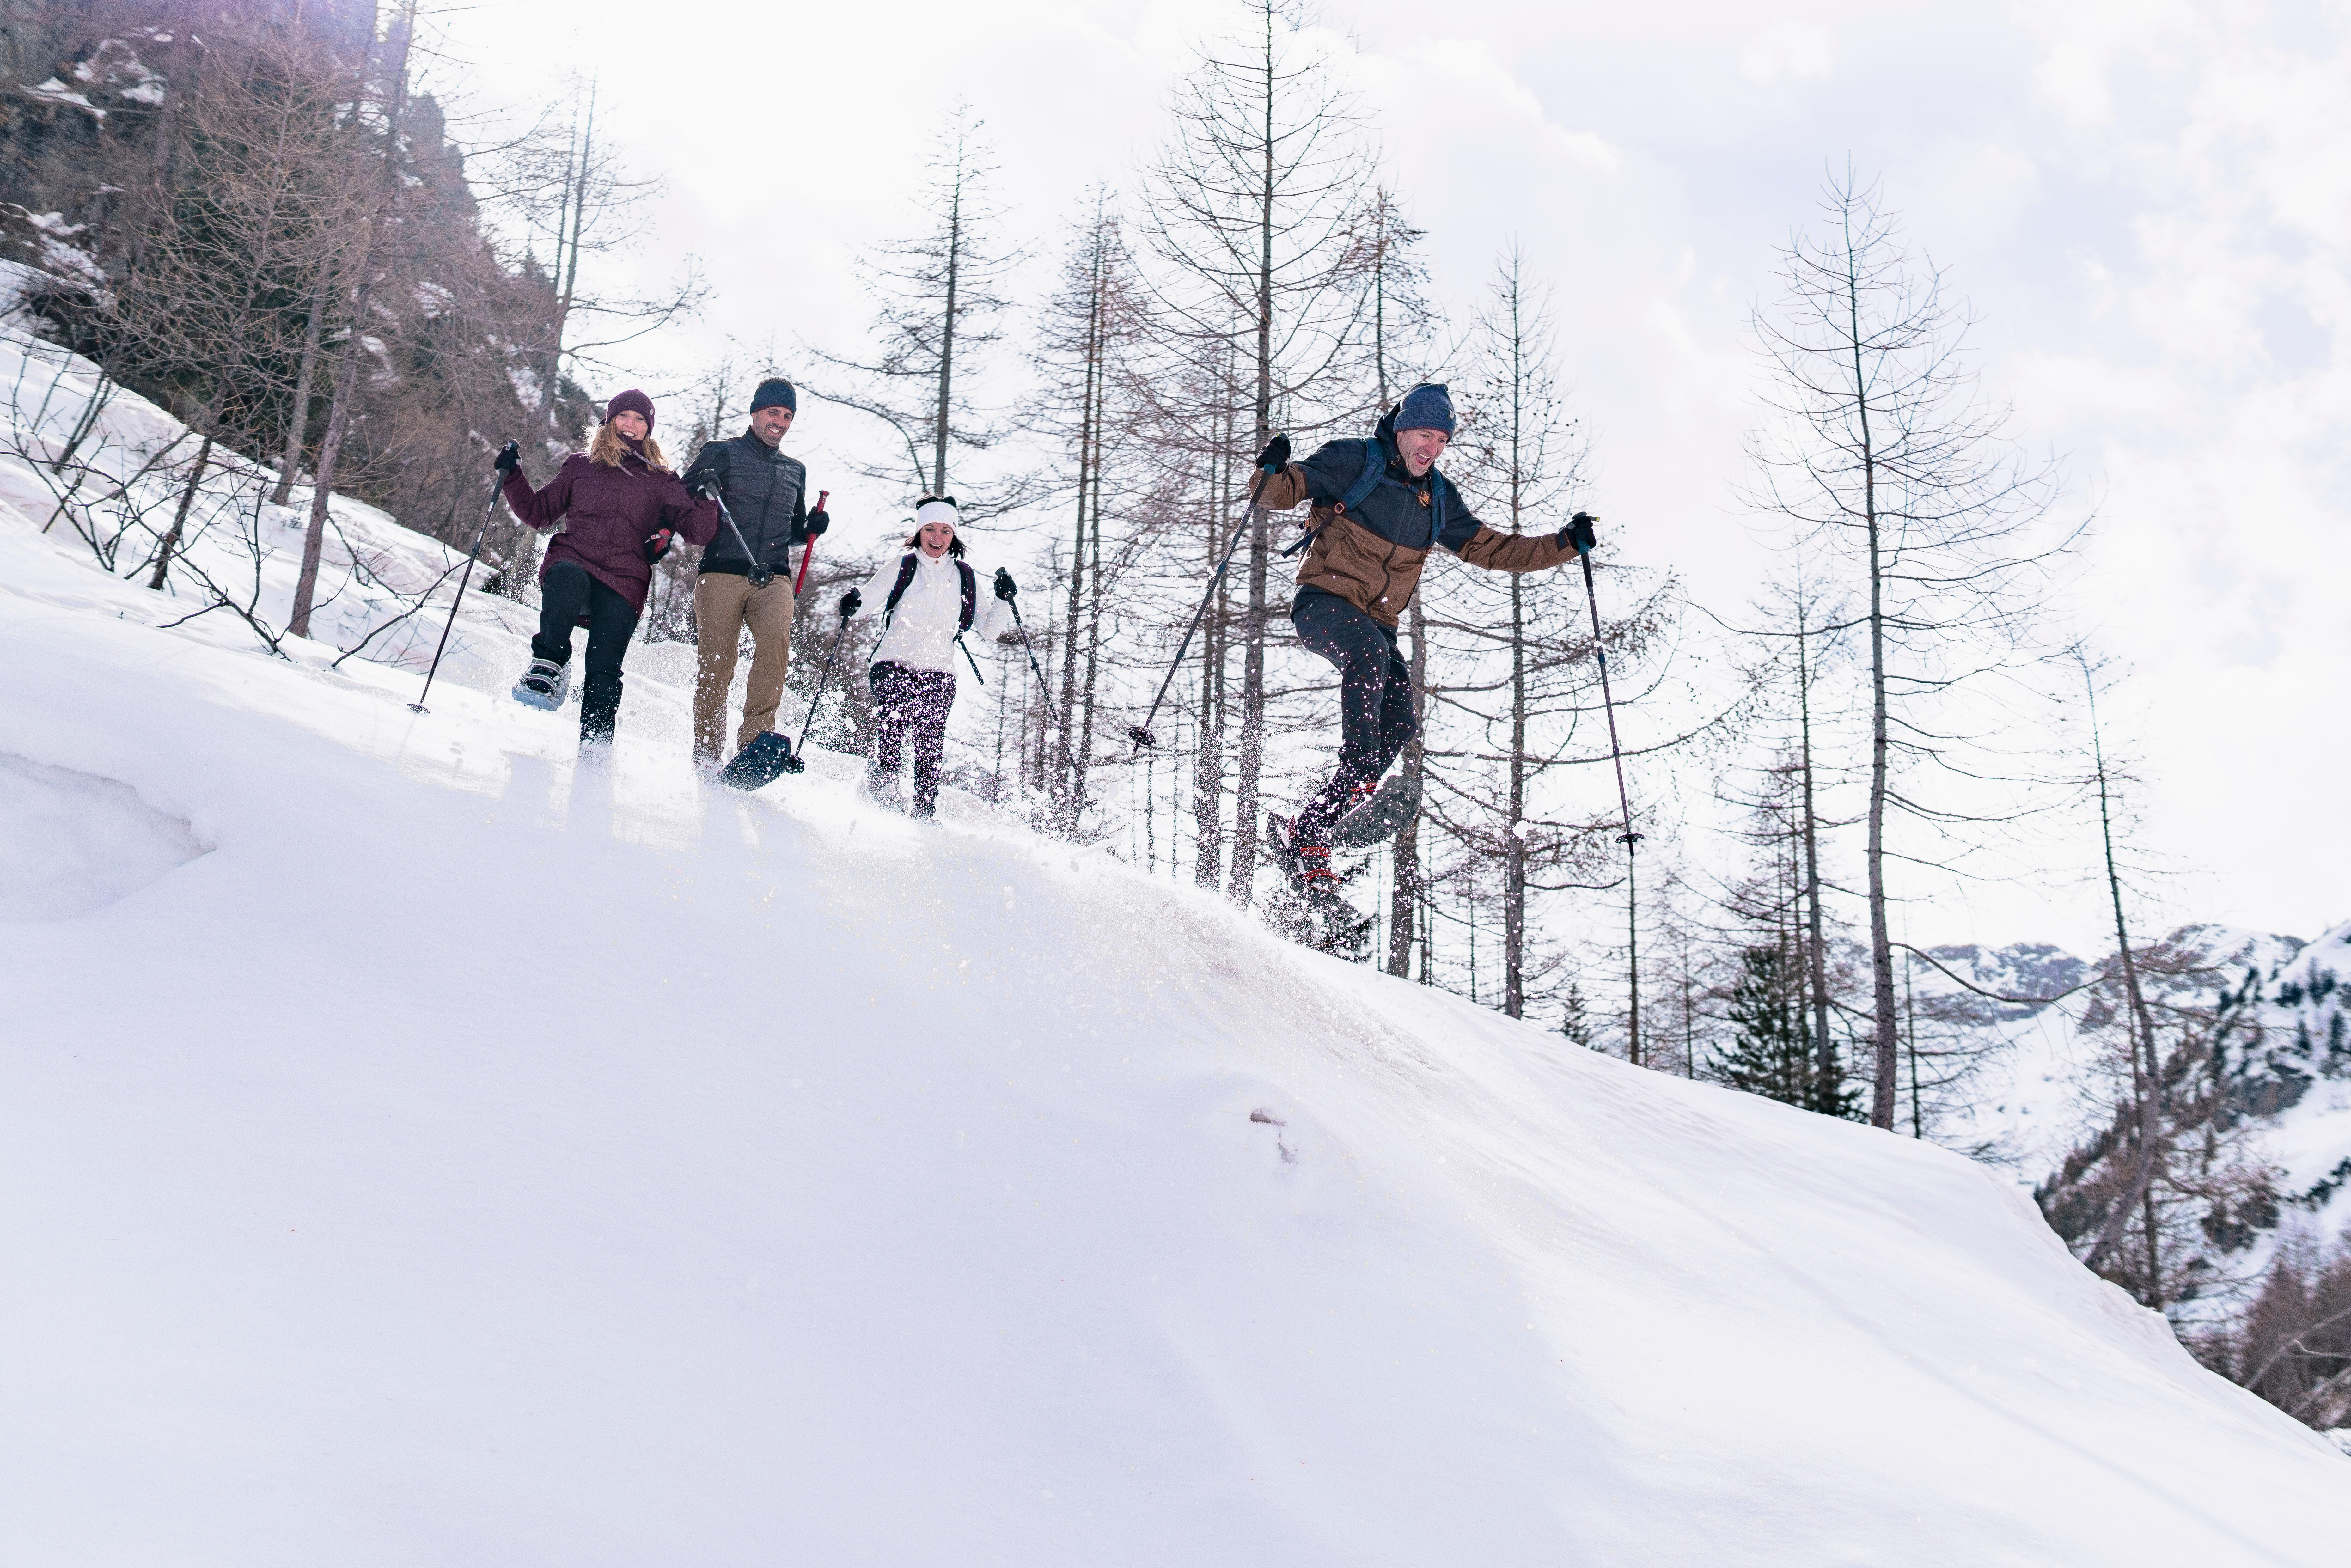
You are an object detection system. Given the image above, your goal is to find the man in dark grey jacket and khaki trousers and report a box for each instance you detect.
[687,376,832,769]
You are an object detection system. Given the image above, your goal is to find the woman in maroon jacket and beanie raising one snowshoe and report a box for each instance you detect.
[498,390,719,743]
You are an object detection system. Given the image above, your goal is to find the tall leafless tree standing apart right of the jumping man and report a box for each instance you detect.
[1751,174,2071,1128]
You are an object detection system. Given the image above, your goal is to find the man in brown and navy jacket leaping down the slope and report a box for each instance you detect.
[1258,383,1592,926]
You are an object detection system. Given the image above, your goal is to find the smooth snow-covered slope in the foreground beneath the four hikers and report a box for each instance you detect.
[0,409,2351,1568]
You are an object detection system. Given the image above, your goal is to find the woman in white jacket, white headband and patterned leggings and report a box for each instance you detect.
[844,496,1018,816]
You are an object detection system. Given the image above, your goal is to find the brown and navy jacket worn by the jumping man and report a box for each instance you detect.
[1258,416,1575,625]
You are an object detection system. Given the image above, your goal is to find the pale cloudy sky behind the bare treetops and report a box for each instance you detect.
[437,0,2351,947]
